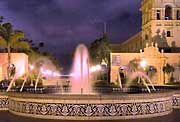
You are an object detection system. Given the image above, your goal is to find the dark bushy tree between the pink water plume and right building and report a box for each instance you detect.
[90,34,111,64]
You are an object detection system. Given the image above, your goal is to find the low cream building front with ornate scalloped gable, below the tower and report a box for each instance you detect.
[110,43,180,85]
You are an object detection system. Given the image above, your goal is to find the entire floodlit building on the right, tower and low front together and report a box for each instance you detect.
[110,0,180,85]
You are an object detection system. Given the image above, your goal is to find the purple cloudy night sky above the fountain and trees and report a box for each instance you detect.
[0,0,141,72]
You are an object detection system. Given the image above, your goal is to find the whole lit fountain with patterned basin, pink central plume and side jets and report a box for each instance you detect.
[0,44,175,120]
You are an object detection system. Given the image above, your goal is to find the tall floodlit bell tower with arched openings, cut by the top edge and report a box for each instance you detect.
[141,0,180,47]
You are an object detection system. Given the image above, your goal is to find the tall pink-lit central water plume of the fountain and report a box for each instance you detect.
[70,44,91,94]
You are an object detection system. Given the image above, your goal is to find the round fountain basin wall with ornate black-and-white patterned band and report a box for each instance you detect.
[0,92,180,120]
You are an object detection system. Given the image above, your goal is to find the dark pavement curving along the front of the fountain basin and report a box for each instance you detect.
[0,109,180,122]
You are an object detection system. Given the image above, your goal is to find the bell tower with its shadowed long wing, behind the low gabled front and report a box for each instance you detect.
[115,0,180,53]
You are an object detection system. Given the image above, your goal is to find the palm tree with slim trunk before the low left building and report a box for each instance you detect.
[0,23,30,80]
